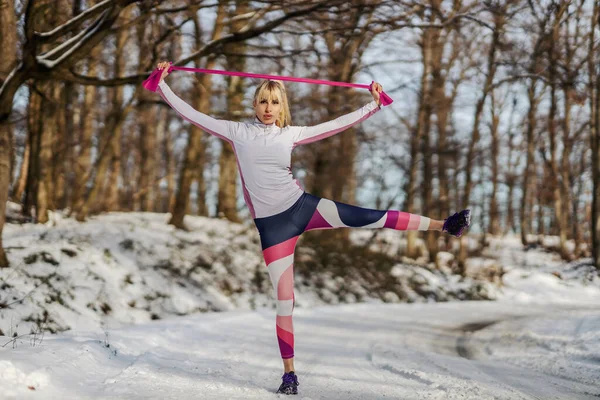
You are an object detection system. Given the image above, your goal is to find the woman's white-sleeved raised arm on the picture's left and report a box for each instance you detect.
[156,80,238,141]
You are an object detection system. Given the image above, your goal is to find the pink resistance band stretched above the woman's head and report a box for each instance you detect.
[143,65,394,106]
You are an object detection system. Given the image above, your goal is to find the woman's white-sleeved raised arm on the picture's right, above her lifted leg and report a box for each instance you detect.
[294,100,381,146]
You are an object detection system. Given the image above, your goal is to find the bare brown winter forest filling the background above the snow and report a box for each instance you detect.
[0,0,600,271]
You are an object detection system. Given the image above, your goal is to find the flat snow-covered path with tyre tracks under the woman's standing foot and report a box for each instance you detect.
[0,302,600,400]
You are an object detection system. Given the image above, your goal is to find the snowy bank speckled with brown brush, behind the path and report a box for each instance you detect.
[0,208,506,336]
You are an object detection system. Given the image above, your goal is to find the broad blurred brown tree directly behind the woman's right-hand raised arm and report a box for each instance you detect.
[304,0,381,206]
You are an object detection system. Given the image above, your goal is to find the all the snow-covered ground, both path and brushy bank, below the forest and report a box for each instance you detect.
[0,208,600,399]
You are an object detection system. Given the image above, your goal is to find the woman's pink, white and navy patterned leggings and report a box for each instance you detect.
[254,193,429,359]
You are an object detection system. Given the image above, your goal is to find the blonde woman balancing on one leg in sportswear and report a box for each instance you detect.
[157,62,470,394]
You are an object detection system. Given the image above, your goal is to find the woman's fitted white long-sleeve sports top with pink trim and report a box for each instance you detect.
[158,80,380,218]
